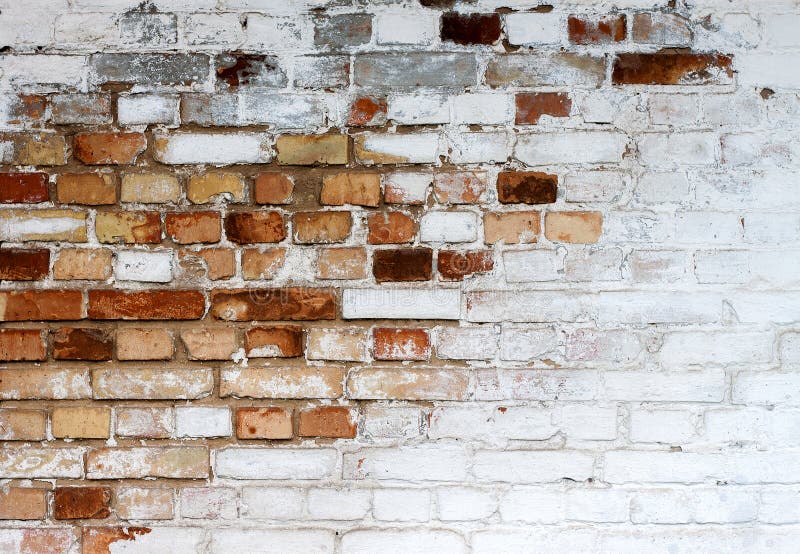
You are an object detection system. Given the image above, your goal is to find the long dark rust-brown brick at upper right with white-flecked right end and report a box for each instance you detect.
[611,52,733,85]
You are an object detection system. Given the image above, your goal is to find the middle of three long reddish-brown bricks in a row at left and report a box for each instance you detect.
[89,290,205,319]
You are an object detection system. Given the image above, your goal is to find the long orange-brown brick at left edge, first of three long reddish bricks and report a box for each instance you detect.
[0,290,83,321]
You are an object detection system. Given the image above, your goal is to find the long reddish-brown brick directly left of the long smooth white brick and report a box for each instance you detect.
[211,287,336,321]
